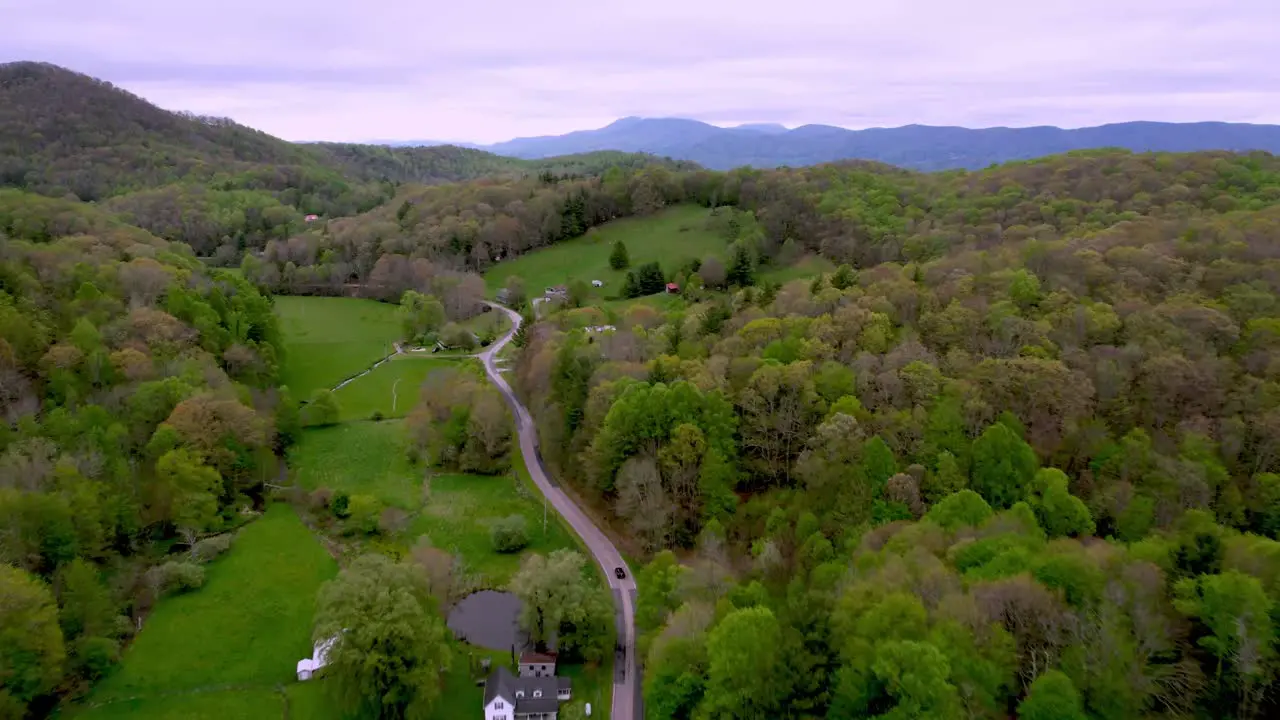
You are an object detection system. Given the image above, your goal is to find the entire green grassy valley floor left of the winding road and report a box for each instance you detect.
[63,297,613,720]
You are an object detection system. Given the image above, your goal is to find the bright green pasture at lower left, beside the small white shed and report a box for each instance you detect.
[78,505,338,719]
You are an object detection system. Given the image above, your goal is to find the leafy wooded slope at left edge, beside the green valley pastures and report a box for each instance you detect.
[0,191,293,717]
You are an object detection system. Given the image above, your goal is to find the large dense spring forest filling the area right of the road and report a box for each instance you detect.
[496,152,1280,719]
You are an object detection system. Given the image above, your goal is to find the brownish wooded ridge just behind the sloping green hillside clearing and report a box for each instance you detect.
[242,165,690,299]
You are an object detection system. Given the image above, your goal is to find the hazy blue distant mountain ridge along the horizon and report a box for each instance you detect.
[404,118,1280,170]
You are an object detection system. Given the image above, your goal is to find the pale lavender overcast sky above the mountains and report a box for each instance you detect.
[0,0,1280,143]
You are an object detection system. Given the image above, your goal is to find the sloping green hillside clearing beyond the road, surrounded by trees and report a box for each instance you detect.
[485,205,728,297]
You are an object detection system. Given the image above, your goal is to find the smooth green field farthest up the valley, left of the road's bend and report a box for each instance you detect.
[275,296,401,400]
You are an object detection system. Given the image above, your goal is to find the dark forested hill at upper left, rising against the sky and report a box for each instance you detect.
[0,63,690,265]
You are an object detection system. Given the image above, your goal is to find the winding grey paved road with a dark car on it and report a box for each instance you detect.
[477,302,641,720]
